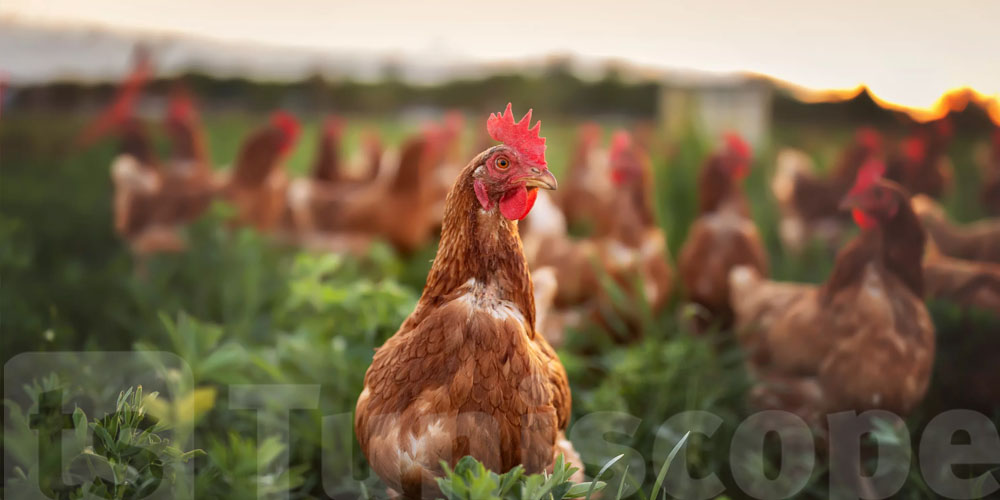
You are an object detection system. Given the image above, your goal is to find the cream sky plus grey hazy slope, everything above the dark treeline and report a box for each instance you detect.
[0,0,1000,120]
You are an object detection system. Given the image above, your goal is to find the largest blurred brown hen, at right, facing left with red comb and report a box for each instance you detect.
[730,169,935,423]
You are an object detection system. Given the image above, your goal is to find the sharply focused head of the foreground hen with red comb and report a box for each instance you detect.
[472,104,557,220]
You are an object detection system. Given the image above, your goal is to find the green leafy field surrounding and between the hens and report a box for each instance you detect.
[0,111,1000,498]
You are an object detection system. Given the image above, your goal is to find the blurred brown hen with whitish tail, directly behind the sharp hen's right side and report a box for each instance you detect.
[523,131,673,340]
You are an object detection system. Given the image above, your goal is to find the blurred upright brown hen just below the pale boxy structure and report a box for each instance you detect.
[677,135,768,326]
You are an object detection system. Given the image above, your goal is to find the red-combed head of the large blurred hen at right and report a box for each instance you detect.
[840,160,908,229]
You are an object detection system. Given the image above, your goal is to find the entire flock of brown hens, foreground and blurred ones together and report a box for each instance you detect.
[88,63,1000,495]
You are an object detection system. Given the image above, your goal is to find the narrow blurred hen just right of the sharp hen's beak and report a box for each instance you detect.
[557,123,611,232]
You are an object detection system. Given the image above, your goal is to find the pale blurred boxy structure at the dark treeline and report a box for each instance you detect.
[659,73,772,147]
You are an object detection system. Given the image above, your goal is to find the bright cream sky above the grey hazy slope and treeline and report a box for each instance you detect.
[0,0,1000,112]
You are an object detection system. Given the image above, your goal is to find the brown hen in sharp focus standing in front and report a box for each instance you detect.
[355,105,575,498]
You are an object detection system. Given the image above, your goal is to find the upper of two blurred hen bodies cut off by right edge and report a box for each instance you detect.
[913,195,1000,264]
